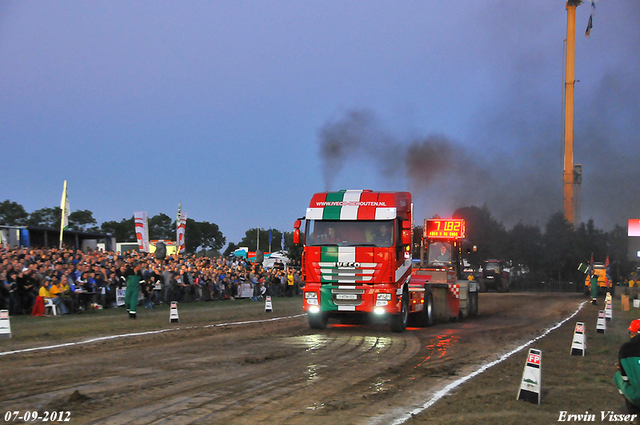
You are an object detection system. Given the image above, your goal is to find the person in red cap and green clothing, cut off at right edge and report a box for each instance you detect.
[613,319,640,416]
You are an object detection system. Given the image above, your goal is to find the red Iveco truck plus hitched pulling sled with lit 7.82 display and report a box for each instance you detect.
[294,190,478,332]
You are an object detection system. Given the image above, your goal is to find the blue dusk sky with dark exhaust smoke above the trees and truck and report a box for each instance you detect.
[0,0,640,243]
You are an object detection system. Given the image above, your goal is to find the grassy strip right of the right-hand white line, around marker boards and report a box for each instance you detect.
[408,298,640,425]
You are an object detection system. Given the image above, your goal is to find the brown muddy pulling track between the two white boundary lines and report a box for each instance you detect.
[0,293,584,424]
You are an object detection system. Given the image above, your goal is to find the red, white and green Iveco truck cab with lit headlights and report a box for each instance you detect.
[294,190,422,332]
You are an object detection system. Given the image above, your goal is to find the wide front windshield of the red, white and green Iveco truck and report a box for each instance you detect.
[305,220,395,247]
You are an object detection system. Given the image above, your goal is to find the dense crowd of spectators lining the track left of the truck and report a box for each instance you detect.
[0,244,303,315]
